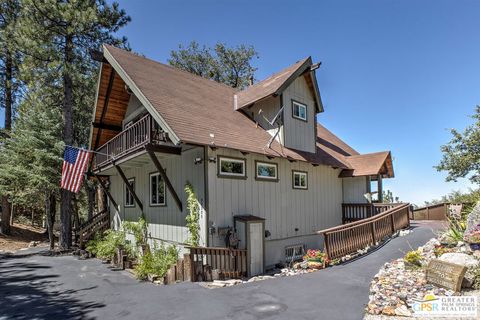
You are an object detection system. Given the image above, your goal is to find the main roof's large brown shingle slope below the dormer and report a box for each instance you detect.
[99,46,392,178]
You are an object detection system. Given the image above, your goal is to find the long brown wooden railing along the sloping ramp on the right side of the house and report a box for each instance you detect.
[317,203,410,259]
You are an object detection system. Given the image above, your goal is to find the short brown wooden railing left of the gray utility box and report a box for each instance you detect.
[188,247,247,282]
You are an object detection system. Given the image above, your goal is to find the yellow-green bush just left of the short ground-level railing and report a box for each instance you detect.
[135,243,178,280]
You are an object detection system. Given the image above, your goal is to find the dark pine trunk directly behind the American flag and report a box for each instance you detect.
[60,35,73,249]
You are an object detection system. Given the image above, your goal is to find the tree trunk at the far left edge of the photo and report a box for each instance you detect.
[1,49,13,234]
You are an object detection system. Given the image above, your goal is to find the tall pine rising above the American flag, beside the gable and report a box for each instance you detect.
[13,0,130,248]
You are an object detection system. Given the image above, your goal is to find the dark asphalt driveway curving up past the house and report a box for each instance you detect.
[0,222,440,320]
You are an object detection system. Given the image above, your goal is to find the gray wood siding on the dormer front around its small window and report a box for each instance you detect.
[282,76,316,152]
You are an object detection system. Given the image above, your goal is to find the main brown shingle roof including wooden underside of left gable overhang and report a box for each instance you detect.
[91,46,394,178]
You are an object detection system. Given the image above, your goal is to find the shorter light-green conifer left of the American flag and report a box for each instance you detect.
[0,87,64,249]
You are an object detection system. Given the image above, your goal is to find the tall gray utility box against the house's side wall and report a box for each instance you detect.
[233,215,265,277]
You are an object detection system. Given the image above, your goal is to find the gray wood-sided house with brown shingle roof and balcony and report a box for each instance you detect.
[90,46,394,274]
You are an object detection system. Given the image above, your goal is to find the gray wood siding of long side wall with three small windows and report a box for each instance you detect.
[208,148,342,246]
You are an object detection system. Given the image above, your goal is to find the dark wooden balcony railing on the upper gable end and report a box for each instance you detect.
[94,114,167,168]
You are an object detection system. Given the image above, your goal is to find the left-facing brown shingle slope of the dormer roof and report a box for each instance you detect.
[235,57,312,110]
